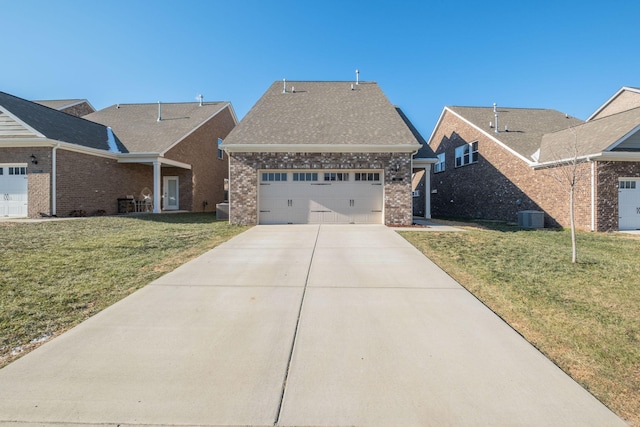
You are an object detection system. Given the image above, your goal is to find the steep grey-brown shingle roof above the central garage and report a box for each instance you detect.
[225,81,418,149]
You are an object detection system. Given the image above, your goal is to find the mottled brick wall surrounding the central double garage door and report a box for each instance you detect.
[229,153,412,225]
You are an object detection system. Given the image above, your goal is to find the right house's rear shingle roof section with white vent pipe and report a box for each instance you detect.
[448,107,583,161]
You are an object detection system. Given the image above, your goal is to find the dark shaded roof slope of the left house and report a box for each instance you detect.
[0,92,127,153]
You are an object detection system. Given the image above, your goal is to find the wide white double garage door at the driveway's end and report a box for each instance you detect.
[258,170,383,224]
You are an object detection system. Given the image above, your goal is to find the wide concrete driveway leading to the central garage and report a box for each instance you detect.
[0,225,626,426]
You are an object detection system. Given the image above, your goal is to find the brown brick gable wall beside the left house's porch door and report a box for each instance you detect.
[163,108,235,212]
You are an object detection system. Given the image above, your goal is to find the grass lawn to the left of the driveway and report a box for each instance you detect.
[0,213,247,367]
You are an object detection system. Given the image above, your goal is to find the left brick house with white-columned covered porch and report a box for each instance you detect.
[0,92,237,217]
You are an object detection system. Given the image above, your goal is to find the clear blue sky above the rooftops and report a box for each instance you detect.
[0,0,640,137]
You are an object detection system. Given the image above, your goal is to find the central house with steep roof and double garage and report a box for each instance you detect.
[222,81,435,225]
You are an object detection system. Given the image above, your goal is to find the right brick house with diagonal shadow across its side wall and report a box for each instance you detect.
[428,87,640,231]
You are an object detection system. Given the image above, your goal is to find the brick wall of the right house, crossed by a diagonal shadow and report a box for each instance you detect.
[431,111,596,229]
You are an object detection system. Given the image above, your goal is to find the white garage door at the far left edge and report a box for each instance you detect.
[0,165,28,217]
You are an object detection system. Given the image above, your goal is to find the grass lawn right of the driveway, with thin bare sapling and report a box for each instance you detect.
[401,224,640,426]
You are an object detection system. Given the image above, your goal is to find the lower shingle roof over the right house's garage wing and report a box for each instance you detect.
[539,108,640,163]
